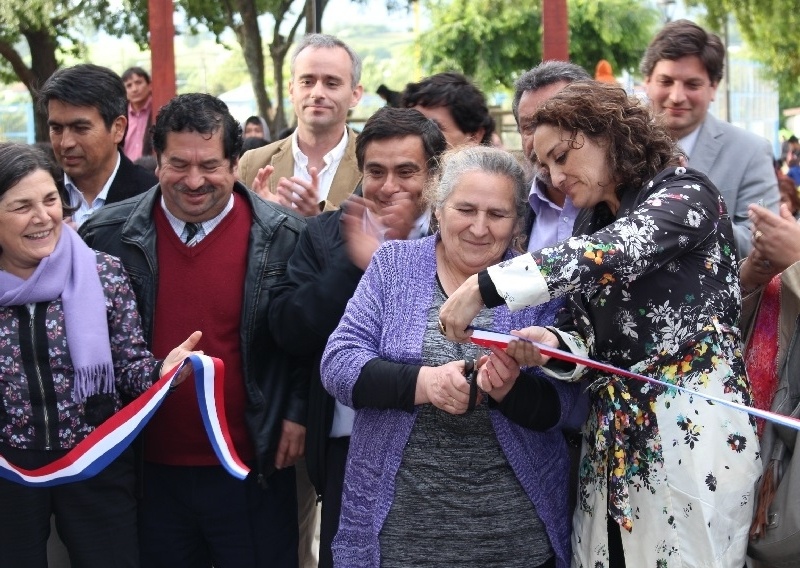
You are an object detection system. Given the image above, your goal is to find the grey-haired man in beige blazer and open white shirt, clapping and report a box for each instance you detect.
[238,34,364,216]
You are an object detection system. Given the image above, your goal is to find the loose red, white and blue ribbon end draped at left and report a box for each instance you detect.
[0,355,250,487]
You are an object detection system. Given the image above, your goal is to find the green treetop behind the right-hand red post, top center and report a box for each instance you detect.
[419,0,659,92]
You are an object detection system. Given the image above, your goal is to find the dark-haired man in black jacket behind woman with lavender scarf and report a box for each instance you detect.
[38,64,158,227]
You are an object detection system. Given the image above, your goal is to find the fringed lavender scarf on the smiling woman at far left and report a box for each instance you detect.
[0,223,114,402]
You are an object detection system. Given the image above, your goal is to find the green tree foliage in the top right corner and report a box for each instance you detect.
[686,0,800,118]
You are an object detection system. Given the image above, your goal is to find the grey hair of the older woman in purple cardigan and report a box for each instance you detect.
[429,146,528,229]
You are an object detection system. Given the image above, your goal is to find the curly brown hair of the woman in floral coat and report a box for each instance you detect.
[532,81,681,196]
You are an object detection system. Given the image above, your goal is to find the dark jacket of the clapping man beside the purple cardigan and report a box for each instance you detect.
[269,209,363,495]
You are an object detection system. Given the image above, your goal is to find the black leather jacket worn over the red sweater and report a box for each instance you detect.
[80,182,308,481]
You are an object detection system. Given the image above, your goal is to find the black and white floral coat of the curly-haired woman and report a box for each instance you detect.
[489,167,761,568]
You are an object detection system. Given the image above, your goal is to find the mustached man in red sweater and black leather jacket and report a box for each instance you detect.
[82,93,305,568]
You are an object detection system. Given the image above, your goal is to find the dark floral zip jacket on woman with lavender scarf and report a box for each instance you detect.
[0,252,158,450]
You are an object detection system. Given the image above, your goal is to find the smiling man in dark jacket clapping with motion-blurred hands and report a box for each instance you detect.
[269,106,447,568]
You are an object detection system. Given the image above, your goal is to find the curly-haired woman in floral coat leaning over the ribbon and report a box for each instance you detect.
[440,82,760,568]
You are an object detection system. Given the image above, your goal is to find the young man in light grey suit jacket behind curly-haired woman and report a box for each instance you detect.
[639,20,780,258]
